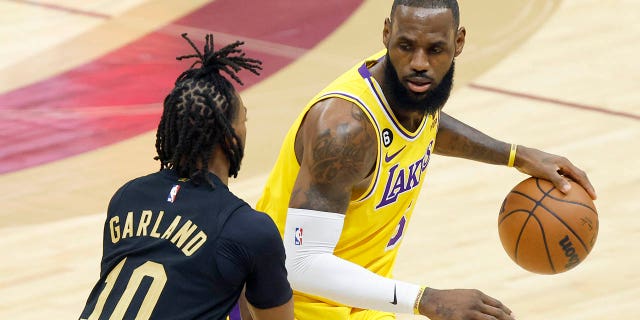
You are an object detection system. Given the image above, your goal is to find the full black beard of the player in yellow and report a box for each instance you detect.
[384,53,456,114]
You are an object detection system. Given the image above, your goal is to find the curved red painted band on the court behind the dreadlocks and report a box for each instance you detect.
[0,0,362,174]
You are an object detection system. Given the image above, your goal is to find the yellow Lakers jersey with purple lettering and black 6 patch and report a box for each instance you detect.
[257,51,438,277]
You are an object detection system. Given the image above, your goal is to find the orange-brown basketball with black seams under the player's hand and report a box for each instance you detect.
[498,178,598,274]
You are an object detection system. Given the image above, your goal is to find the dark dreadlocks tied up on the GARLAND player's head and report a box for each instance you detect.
[154,33,262,186]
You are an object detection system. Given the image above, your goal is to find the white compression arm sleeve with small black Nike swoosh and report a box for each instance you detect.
[284,208,420,314]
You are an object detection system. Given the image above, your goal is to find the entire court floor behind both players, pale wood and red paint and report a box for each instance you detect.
[0,0,640,320]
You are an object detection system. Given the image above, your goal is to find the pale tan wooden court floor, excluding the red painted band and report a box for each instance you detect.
[0,0,640,320]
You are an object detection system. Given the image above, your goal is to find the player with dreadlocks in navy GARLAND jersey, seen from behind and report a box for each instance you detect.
[81,34,293,320]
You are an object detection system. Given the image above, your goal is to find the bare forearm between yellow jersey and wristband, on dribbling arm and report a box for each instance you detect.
[434,112,511,165]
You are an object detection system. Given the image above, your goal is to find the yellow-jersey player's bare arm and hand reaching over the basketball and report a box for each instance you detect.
[434,112,596,199]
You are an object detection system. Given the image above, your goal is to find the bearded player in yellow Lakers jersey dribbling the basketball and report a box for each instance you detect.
[252,0,595,320]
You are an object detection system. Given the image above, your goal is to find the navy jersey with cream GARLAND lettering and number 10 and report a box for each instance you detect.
[81,170,292,319]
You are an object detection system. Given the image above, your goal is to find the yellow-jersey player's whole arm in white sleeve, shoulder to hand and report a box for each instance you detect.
[284,99,513,320]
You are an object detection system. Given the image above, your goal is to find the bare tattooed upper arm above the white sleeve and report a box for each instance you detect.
[290,99,376,213]
